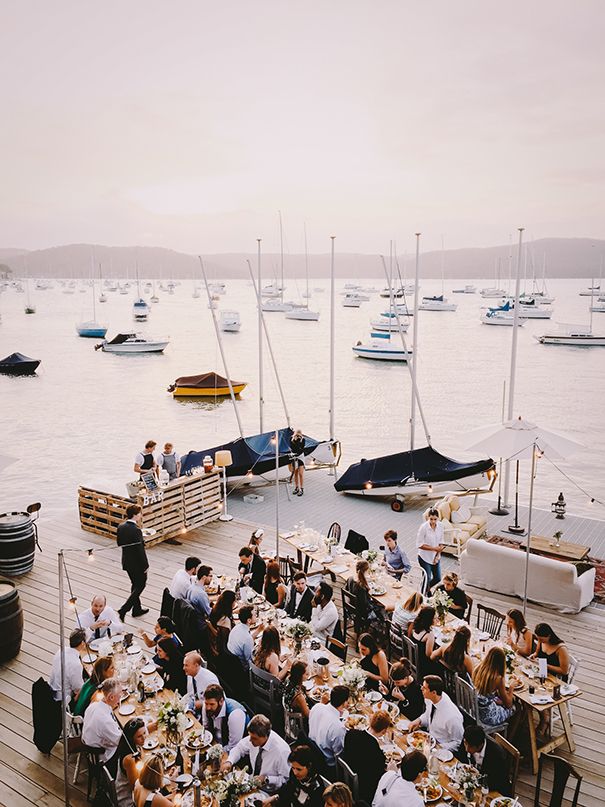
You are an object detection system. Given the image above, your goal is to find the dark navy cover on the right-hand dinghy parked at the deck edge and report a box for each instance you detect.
[334,446,494,492]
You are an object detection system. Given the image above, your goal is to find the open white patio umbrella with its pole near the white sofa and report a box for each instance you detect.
[466,417,583,611]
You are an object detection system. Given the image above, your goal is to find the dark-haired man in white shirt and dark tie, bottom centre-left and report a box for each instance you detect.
[222,715,290,791]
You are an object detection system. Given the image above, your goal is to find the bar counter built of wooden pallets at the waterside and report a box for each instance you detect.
[78,471,222,545]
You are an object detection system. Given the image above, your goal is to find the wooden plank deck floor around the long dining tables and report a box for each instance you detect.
[0,502,605,807]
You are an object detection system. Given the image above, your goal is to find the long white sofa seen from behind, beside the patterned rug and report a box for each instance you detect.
[460,538,595,614]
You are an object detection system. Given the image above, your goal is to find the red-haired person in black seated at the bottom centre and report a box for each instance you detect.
[342,710,393,804]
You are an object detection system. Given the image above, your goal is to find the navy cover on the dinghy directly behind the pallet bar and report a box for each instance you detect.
[181,428,319,476]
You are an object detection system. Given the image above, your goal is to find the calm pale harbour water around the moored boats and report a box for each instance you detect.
[0,279,605,518]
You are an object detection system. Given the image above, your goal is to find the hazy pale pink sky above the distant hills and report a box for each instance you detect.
[0,0,605,252]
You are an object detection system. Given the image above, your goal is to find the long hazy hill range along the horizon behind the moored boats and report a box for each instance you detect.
[0,238,605,280]
